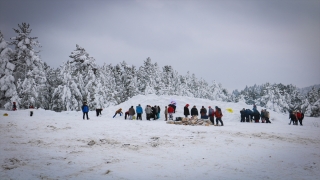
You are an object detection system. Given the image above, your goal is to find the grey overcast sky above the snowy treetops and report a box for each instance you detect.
[0,0,320,90]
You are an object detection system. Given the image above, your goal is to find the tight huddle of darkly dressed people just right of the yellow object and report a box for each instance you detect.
[240,105,271,123]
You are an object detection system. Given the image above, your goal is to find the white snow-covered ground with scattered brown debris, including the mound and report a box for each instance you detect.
[0,95,320,180]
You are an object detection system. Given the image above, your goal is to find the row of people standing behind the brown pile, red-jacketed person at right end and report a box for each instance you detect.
[183,104,223,126]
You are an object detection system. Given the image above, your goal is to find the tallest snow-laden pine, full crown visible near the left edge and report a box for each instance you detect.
[10,23,46,108]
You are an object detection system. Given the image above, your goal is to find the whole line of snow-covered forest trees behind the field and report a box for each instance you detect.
[0,23,320,116]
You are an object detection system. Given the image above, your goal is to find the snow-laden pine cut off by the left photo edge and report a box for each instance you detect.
[0,31,19,110]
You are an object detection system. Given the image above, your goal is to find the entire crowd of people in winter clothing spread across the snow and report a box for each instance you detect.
[79,102,304,126]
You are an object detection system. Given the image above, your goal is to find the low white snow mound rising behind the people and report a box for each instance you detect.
[104,94,289,123]
